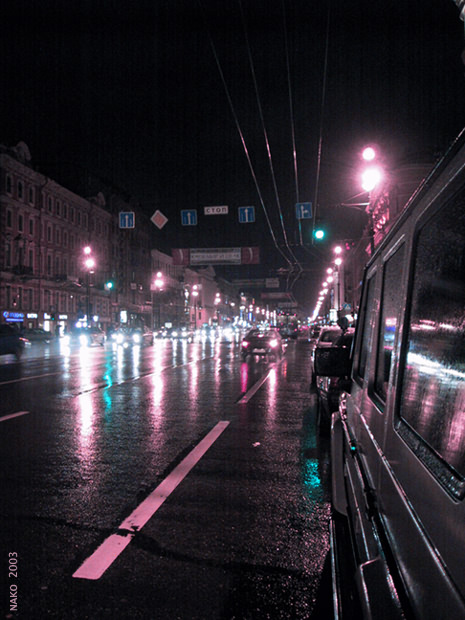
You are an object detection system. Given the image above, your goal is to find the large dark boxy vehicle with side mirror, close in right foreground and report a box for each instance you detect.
[315,132,465,620]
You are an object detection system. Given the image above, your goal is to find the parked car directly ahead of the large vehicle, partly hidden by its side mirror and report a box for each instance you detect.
[315,328,355,432]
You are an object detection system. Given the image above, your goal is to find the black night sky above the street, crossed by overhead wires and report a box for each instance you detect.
[0,0,465,310]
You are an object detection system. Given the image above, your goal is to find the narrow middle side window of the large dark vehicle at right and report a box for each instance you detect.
[375,245,405,402]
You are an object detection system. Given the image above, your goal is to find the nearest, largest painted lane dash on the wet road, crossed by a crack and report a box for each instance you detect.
[73,420,229,579]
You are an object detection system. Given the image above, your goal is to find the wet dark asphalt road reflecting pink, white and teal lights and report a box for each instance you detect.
[0,340,331,620]
